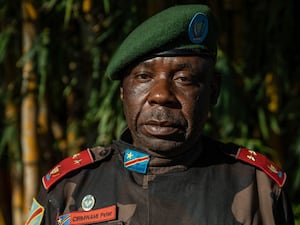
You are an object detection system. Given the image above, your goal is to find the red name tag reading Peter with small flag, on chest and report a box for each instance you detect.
[56,205,117,225]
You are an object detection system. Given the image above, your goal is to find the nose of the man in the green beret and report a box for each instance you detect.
[148,78,179,107]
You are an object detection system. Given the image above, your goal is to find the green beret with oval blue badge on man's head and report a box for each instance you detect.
[106,4,217,80]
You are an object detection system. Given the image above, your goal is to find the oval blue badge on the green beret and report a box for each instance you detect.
[188,13,208,44]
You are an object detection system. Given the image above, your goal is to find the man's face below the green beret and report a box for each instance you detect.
[120,56,218,155]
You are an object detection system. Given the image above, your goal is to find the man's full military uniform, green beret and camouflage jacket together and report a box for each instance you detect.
[26,5,293,225]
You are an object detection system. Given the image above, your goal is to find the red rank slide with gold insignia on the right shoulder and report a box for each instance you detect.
[236,148,286,187]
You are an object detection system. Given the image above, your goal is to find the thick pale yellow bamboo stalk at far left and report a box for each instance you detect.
[20,0,39,221]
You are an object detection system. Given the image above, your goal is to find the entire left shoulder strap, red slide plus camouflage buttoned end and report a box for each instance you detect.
[42,147,110,190]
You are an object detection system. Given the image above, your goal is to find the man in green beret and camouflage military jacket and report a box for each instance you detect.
[27,5,293,225]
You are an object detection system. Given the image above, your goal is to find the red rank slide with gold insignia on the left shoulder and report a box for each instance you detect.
[42,149,94,190]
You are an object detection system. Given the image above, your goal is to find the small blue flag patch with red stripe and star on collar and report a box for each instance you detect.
[124,149,150,174]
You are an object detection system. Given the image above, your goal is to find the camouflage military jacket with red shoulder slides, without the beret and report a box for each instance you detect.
[26,134,294,225]
